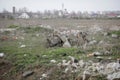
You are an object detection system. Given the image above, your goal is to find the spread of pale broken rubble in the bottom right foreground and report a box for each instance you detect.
[57,56,120,80]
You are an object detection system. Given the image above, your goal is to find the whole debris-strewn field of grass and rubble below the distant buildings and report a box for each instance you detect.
[0,19,120,80]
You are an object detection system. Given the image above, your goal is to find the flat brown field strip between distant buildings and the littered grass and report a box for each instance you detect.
[0,19,120,29]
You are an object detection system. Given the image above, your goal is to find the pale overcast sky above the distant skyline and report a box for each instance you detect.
[0,0,120,12]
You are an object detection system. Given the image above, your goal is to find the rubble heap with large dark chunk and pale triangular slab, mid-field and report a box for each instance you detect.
[46,31,89,48]
